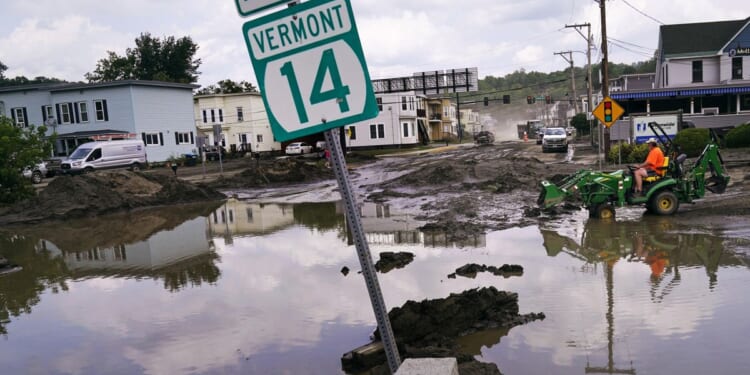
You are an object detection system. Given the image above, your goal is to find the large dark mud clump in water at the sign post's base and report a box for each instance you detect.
[341,287,545,374]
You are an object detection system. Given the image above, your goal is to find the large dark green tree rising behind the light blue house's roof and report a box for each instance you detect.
[85,33,201,83]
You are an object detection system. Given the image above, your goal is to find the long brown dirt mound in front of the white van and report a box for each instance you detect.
[0,170,224,223]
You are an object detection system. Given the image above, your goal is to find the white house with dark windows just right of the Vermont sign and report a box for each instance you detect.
[346,91,424,148]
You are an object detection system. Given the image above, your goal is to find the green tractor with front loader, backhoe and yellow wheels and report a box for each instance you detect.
[537,122,729,219]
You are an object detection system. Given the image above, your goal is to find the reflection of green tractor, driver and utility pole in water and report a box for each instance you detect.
[540,217,740,374]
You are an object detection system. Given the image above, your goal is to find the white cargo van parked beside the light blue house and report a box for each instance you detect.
[60,139,146,173]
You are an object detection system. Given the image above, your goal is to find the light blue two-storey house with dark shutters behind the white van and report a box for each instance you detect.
[0,80,197,162]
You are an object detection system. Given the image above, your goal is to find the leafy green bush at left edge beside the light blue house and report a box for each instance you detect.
[0,117,52,204]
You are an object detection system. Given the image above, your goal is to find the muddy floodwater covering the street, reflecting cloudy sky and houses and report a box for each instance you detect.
[0,200,750,374]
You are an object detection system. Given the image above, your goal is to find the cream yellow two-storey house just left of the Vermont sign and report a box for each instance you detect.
[193,92,281,152]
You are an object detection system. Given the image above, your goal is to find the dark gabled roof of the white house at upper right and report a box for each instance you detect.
[659,19,748,57]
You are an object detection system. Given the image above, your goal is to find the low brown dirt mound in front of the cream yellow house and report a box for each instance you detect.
[208,158,334,189]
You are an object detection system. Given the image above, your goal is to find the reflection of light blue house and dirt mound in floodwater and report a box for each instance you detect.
[0,204,221,334]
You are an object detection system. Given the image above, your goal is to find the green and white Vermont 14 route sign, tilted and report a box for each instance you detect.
[243,0,378,141]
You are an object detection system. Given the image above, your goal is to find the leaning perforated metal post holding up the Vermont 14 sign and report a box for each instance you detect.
[324,127,401,374]
